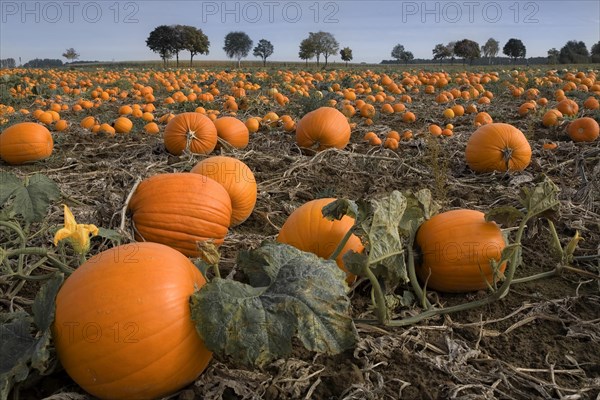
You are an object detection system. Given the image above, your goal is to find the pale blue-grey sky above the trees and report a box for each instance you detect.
[0,0,600,63]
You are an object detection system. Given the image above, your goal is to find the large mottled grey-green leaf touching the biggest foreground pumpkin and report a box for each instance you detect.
[191,243,358,366]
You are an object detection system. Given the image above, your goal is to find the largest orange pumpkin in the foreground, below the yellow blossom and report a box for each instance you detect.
[52,243,212,399]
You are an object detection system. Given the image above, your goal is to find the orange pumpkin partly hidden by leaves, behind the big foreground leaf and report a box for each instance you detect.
[277,198,364,283]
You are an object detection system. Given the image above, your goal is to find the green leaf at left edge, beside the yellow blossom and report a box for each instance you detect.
[0,172,60,223]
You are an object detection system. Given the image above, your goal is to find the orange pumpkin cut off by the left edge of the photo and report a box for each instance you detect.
[0,122,54,165]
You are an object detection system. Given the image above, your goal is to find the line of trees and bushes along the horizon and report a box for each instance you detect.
[0,25,600,68]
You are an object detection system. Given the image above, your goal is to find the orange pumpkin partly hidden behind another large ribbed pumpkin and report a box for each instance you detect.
[191,156,257,226]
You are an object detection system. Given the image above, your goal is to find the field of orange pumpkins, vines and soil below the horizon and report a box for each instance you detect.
[0,64,600,400]
